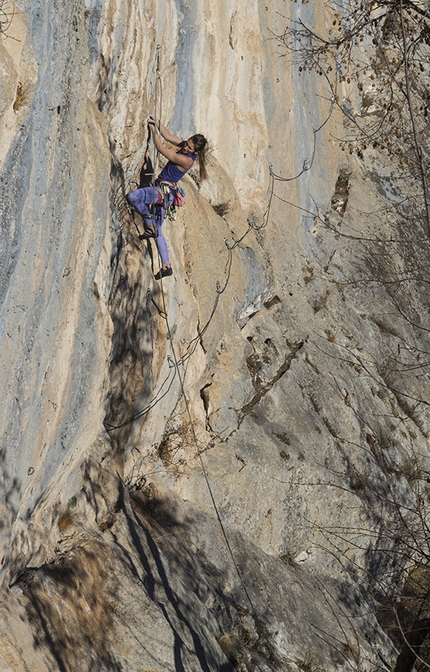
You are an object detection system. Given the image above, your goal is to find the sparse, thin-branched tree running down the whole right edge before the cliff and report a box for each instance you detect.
[275,0,430,672]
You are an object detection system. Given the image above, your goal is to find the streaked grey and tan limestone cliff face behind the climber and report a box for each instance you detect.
[0,0,430,672]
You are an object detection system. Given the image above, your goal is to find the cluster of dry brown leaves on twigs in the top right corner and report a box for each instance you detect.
[277,0,430,235]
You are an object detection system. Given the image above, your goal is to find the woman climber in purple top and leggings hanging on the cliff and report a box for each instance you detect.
[127,116,207,280]
